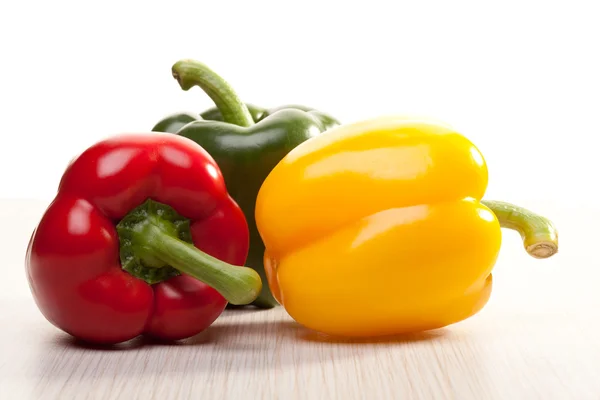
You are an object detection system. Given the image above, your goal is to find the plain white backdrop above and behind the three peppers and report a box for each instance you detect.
[0,0,600,213]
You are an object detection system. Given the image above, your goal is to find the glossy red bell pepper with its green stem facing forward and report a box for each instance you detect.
[26,133,262,344]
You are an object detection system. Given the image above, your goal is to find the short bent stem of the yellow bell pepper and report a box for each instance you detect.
[481,200,558,258]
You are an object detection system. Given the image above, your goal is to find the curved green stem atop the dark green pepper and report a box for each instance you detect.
[171,59,254,127]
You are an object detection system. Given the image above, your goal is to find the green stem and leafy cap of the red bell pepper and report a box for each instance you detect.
[117,199,262,305]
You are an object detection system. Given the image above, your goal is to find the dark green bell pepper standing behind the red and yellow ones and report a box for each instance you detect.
[152,60,339,308]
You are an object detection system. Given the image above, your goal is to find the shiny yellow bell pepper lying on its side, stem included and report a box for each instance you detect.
[255,117,558,337]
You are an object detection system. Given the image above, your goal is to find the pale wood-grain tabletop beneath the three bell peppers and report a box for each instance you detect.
[0,200,600,400]
